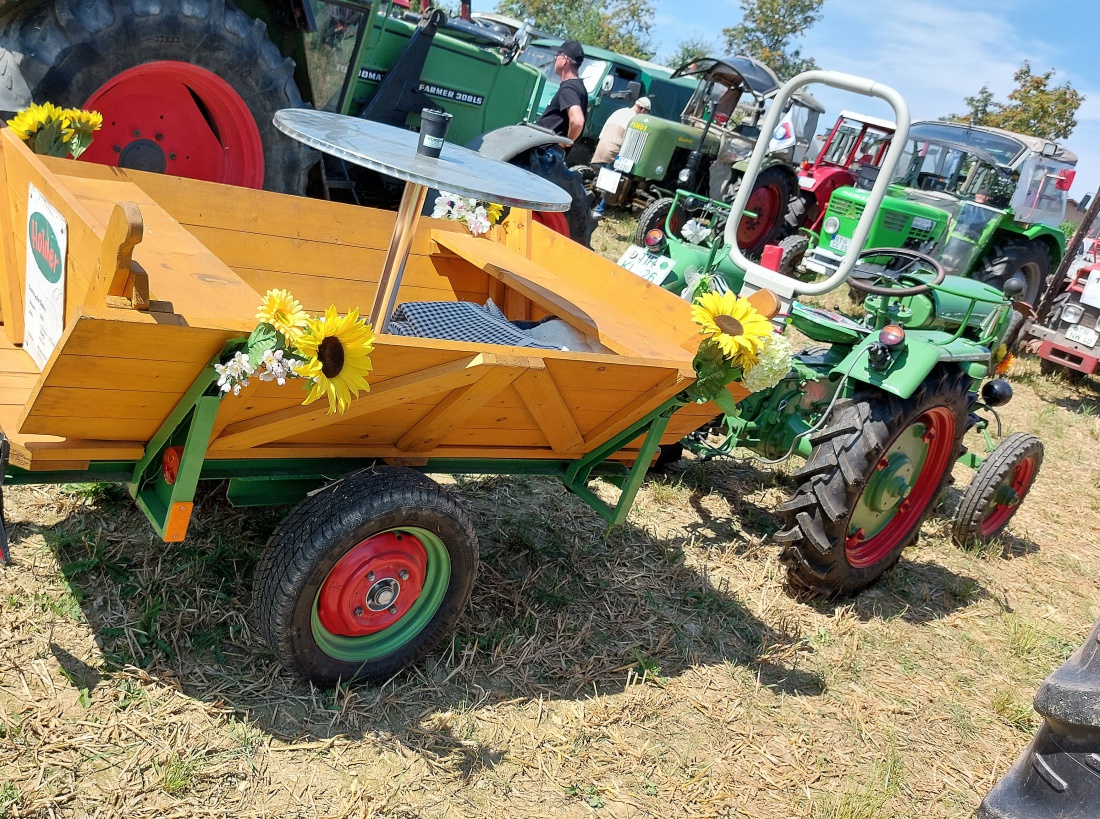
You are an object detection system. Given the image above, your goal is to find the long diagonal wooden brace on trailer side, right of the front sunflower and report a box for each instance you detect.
[211,355,496,450]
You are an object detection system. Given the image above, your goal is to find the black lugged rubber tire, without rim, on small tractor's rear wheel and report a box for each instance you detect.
[776,370,969,596]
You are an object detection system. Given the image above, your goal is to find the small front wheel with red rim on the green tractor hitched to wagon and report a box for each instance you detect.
[953,432,1043,549]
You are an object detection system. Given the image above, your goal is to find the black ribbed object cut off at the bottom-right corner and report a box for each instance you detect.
[978,622,1100,819]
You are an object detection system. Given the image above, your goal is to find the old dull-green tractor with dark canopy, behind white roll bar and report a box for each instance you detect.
[596,56,825,255]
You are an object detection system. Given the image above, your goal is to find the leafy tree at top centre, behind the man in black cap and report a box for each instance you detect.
[499,0,655,59]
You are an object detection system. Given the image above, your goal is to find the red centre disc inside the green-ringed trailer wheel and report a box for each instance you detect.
[317,532,428,637]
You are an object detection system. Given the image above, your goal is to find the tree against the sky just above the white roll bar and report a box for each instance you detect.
[722,0,825,80]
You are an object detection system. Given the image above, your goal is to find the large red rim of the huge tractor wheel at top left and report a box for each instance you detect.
[80,60,264,188]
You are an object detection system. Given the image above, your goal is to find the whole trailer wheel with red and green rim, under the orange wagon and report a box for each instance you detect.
[253,467,477,687]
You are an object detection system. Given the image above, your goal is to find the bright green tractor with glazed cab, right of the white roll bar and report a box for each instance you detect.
[784,122,1077,305]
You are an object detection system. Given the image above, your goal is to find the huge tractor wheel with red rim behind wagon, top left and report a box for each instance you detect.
[0,0,315,193]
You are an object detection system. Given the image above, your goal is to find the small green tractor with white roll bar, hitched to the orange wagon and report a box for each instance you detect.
[635,71,1043,594]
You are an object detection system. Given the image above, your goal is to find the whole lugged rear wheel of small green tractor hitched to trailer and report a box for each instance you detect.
[776,372,968,596]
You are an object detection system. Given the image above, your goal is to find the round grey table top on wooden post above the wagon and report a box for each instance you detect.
[275,108,571,211]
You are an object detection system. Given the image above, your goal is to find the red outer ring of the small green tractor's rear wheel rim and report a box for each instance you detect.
[844,407,955,568]
